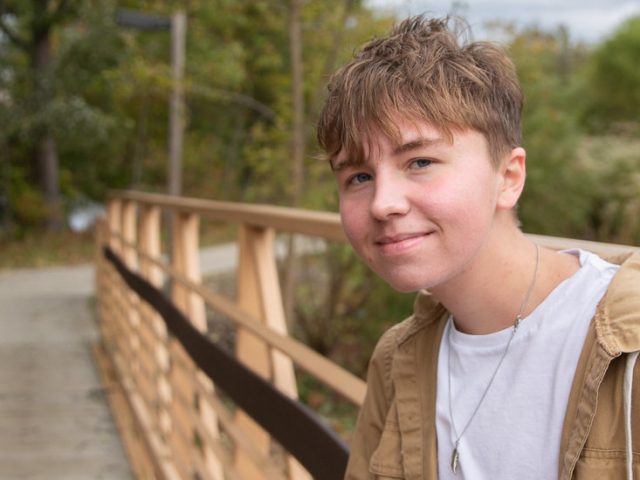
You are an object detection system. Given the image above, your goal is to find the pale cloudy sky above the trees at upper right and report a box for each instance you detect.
[368,0,640,43]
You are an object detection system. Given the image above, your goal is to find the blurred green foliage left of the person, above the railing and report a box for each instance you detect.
[0,0,390,222]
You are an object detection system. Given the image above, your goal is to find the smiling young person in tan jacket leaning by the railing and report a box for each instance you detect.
[317,16,640,480]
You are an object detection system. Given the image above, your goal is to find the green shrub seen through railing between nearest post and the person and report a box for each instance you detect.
[293,244,414,376]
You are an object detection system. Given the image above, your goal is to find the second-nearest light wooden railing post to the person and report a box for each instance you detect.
[171,212,224,479]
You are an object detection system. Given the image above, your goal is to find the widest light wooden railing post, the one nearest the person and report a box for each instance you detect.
[235,226,310,480]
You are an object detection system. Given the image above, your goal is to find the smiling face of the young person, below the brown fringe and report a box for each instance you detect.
[332,122,524,292]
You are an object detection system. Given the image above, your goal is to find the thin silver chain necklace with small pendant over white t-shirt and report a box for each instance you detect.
[447,245,540,474]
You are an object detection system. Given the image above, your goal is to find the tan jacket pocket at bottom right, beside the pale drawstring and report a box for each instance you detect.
[573,448,640,480]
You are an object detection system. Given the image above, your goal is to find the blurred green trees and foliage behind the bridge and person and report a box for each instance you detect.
[0,0,640,372]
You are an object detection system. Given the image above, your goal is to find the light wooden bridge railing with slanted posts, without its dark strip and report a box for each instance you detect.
[97,192,637,480]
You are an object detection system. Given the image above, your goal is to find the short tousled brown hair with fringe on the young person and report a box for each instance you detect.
[317,16,523,164]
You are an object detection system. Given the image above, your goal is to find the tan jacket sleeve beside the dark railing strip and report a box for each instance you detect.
[344,327,396,480]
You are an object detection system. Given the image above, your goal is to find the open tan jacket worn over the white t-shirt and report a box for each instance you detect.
[345,254,640,480]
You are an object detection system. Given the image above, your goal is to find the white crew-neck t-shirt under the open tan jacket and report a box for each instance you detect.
[436,250,618,480]
